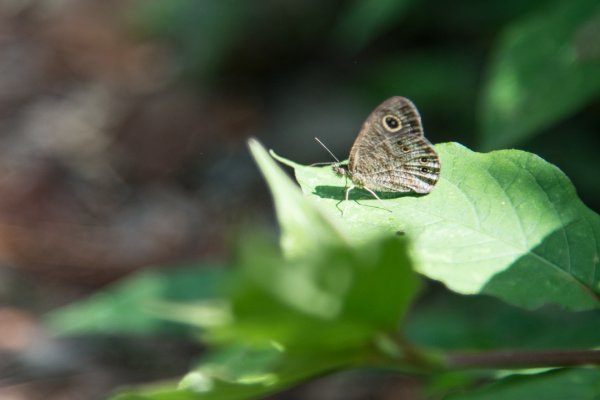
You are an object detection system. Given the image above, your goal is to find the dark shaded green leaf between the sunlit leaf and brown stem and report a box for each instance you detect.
[406,290,600,350]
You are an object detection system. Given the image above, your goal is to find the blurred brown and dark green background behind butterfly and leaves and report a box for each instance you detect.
[0,0,600,400]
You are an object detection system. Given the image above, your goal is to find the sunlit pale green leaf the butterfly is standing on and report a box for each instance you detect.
[272,143,600,310]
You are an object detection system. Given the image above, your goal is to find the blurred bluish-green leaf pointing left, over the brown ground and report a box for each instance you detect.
[45,266,225,335]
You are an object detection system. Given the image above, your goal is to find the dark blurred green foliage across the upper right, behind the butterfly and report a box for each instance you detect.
[123,0,600,209]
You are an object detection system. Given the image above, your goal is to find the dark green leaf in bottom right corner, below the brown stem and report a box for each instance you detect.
[447,368,600,400]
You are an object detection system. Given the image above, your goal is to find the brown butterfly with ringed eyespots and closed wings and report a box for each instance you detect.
[333,96,440,201]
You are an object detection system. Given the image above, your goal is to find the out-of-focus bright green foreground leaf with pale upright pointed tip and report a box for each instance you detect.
[245,141,418,347]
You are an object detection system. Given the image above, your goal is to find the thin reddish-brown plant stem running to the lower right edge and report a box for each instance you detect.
[446,350,600,368]
